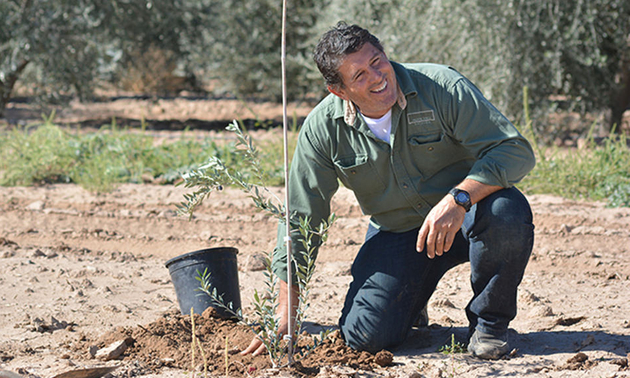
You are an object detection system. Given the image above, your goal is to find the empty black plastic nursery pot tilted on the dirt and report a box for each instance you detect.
[166,247,241,317]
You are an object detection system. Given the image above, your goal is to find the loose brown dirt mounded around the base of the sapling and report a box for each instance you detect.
[74,309,386,377]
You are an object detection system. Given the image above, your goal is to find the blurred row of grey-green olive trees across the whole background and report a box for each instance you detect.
[0,0,630,133]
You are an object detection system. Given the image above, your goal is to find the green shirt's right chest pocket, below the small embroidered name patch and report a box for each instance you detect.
[407,130,464,179]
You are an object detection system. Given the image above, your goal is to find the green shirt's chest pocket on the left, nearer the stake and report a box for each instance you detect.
[334,154,385,195]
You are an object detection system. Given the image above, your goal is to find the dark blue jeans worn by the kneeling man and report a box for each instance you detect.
[339,188,534,352]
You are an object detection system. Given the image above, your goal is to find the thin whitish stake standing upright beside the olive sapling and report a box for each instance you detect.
[281,0,293,366]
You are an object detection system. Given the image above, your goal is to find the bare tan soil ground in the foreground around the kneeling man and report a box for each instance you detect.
[0,98,630,378]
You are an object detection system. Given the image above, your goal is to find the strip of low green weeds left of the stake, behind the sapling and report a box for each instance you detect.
[0,113,295,192]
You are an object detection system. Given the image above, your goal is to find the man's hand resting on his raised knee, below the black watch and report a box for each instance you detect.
[416,194,466,259]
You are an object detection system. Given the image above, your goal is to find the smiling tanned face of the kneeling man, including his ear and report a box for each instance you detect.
[328,43,398,118]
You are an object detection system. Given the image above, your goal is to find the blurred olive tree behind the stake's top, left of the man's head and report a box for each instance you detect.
[205,0,321,100]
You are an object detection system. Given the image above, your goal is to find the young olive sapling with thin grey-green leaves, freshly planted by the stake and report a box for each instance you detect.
[178,121,335,367]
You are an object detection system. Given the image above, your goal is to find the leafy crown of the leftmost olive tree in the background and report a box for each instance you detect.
[0,0,104,115]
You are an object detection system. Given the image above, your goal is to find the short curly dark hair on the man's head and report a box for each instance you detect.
[313,21,383,87]
